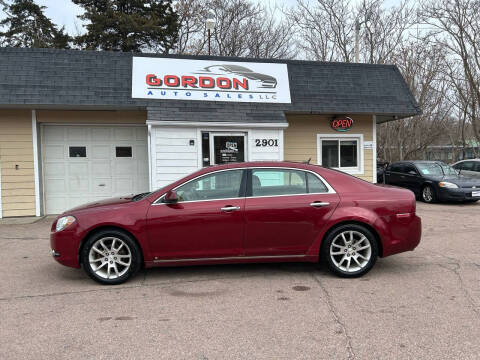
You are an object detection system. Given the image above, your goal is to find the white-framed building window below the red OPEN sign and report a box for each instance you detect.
[318,134,363,174]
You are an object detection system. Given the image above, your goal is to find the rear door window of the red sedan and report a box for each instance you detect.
[252,169,307,196]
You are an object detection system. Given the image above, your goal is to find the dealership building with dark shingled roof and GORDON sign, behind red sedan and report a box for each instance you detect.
[0,48,421,217]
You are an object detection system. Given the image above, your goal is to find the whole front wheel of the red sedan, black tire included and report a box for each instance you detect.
[80,229,142,285]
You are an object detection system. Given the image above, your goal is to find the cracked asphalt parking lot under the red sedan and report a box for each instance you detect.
[0,203,480,359]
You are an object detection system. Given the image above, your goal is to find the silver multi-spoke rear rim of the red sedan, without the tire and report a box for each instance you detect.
[330,230,372,273]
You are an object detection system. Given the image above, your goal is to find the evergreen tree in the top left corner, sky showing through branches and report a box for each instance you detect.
[0,0,70,49]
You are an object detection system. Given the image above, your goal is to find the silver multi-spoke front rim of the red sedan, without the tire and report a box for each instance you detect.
[88,237,132,279]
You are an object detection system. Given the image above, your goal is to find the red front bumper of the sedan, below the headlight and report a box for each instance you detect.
[50,229,80,268]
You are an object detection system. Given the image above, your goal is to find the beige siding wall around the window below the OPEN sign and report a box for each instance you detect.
[284,114,373,181]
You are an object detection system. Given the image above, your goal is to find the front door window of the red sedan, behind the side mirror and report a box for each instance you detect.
[176,169,243,202]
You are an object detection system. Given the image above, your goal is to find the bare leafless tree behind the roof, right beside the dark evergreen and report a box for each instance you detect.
[172,0,293,58]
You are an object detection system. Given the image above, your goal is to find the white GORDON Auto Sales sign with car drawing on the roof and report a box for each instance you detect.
[132,57,291,103]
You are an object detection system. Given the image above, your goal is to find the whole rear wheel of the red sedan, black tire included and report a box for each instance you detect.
[321,224,378,278]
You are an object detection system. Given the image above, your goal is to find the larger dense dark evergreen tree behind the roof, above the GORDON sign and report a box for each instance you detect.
[73,0,179,53]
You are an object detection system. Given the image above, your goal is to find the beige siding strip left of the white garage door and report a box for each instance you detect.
[0,110,35,217]
